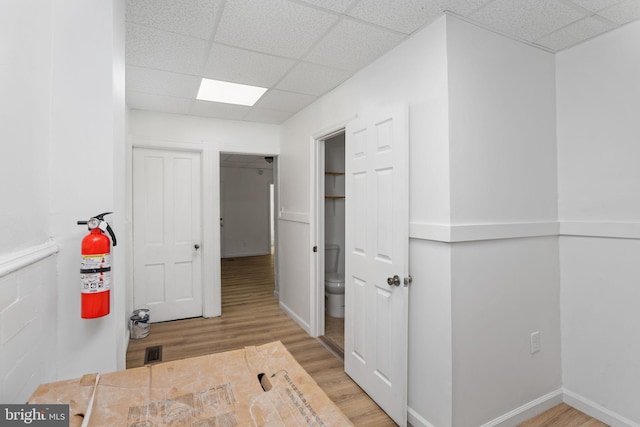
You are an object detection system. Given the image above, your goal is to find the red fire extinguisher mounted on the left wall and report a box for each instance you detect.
[78,212,116,319]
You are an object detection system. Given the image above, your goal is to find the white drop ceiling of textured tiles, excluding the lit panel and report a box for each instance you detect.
[126,0,640,124]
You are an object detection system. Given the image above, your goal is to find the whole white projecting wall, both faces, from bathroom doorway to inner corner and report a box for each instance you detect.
[280,16,561,426]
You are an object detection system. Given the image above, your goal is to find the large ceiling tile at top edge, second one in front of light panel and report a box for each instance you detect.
[214,0,338,58]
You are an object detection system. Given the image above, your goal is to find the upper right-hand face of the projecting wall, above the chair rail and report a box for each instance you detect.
[447,19,557,225]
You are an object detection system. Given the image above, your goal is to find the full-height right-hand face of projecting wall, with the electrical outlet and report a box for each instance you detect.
[447,15,561,426]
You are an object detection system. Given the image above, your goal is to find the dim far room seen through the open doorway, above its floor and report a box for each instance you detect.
[220,153,278,308]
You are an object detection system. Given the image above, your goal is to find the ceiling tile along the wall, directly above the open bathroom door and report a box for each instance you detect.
[305,19,405,71]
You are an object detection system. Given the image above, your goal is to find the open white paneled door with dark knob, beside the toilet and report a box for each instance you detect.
[345,106,409,426]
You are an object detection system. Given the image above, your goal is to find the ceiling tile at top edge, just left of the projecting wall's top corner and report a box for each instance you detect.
[349,0,442,34]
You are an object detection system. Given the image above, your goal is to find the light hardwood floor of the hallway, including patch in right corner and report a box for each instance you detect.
[127,256,605,427]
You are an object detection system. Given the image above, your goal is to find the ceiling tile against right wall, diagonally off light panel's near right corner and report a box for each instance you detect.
[276,62,351,95]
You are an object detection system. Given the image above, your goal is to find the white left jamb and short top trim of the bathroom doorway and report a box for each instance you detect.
[309,123,356,337]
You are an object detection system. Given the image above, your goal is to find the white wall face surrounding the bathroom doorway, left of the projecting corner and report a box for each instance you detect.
[279,18,451,425]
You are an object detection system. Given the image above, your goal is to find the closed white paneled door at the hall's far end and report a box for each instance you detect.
[133,148,202,322]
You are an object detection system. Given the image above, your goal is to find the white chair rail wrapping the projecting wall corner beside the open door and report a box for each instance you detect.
[409,221,559,243]
